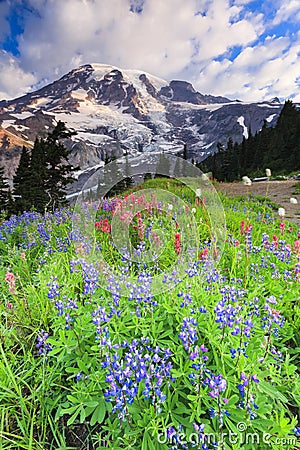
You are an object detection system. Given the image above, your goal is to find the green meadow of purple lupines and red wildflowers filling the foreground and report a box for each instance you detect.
[0,156,300,450]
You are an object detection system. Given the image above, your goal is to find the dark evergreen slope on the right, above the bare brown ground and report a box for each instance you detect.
[200,100,300,181]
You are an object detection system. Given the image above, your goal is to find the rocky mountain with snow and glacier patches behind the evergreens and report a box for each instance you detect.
[0,64,282,185]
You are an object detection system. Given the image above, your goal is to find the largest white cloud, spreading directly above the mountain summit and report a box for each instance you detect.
[19,0,257,77]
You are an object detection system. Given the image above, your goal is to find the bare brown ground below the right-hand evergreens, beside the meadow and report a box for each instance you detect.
[215,180,300,228]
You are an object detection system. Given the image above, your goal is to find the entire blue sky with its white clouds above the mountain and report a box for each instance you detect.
[0,0,300,102]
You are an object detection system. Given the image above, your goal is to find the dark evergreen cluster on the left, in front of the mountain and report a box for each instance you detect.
[0,121,78,216]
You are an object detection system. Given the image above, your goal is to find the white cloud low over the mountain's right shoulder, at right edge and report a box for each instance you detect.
[190,32,300,101]
